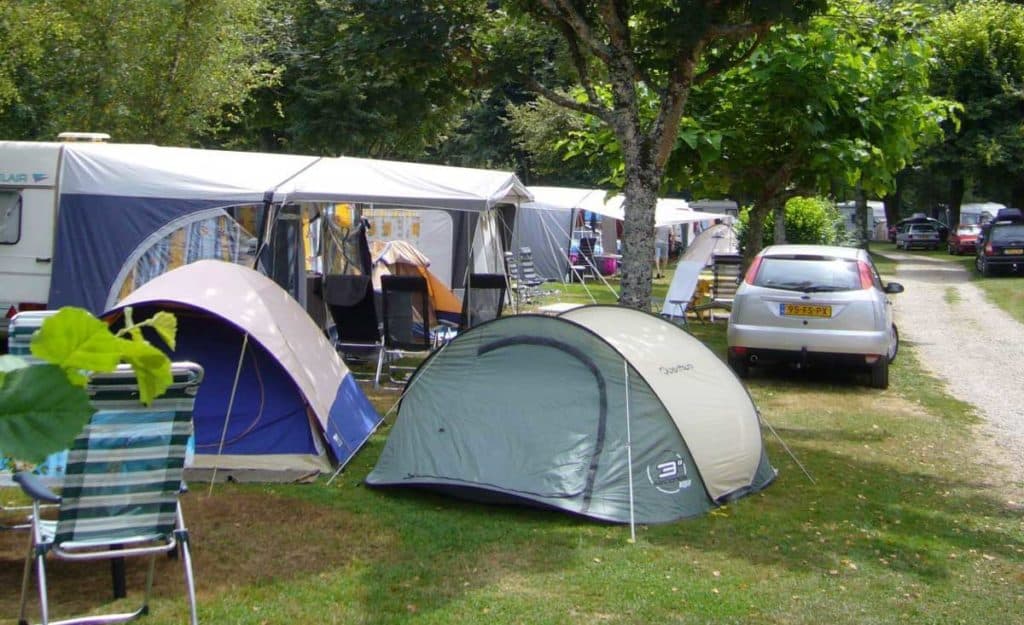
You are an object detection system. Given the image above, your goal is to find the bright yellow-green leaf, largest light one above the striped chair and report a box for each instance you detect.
[31,306,121,385]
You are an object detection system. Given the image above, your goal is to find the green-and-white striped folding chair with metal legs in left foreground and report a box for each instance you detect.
[14,363,203,625]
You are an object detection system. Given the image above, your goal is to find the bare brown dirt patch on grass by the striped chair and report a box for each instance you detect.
[0,485,395,618]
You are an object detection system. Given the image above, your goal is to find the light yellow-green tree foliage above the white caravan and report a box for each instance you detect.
[0,0,272,144]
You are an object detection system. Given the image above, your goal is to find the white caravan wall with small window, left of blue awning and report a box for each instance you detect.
[0,141,61,352]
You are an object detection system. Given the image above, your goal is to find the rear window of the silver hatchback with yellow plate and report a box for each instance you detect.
[754,256,860,292]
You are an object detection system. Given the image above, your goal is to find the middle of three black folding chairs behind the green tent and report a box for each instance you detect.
[374,276,434,387]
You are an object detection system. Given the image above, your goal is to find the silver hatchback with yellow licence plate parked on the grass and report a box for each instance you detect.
[728,245,903,388]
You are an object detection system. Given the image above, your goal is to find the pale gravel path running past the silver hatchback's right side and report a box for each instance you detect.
[887,252,1024,487]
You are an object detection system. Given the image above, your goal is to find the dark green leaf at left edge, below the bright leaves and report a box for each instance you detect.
[0,365,95,462]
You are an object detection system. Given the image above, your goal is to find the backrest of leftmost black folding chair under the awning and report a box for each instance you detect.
[324,275,384,365]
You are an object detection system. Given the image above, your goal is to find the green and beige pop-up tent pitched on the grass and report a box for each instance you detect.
[367,305,775,523]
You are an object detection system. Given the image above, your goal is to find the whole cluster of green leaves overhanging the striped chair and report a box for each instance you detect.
[0,307,177,462]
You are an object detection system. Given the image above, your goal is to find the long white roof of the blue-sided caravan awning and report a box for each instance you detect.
[61,143,531,211]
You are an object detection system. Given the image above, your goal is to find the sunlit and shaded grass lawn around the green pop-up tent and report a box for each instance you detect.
[0,259,1024,625]
